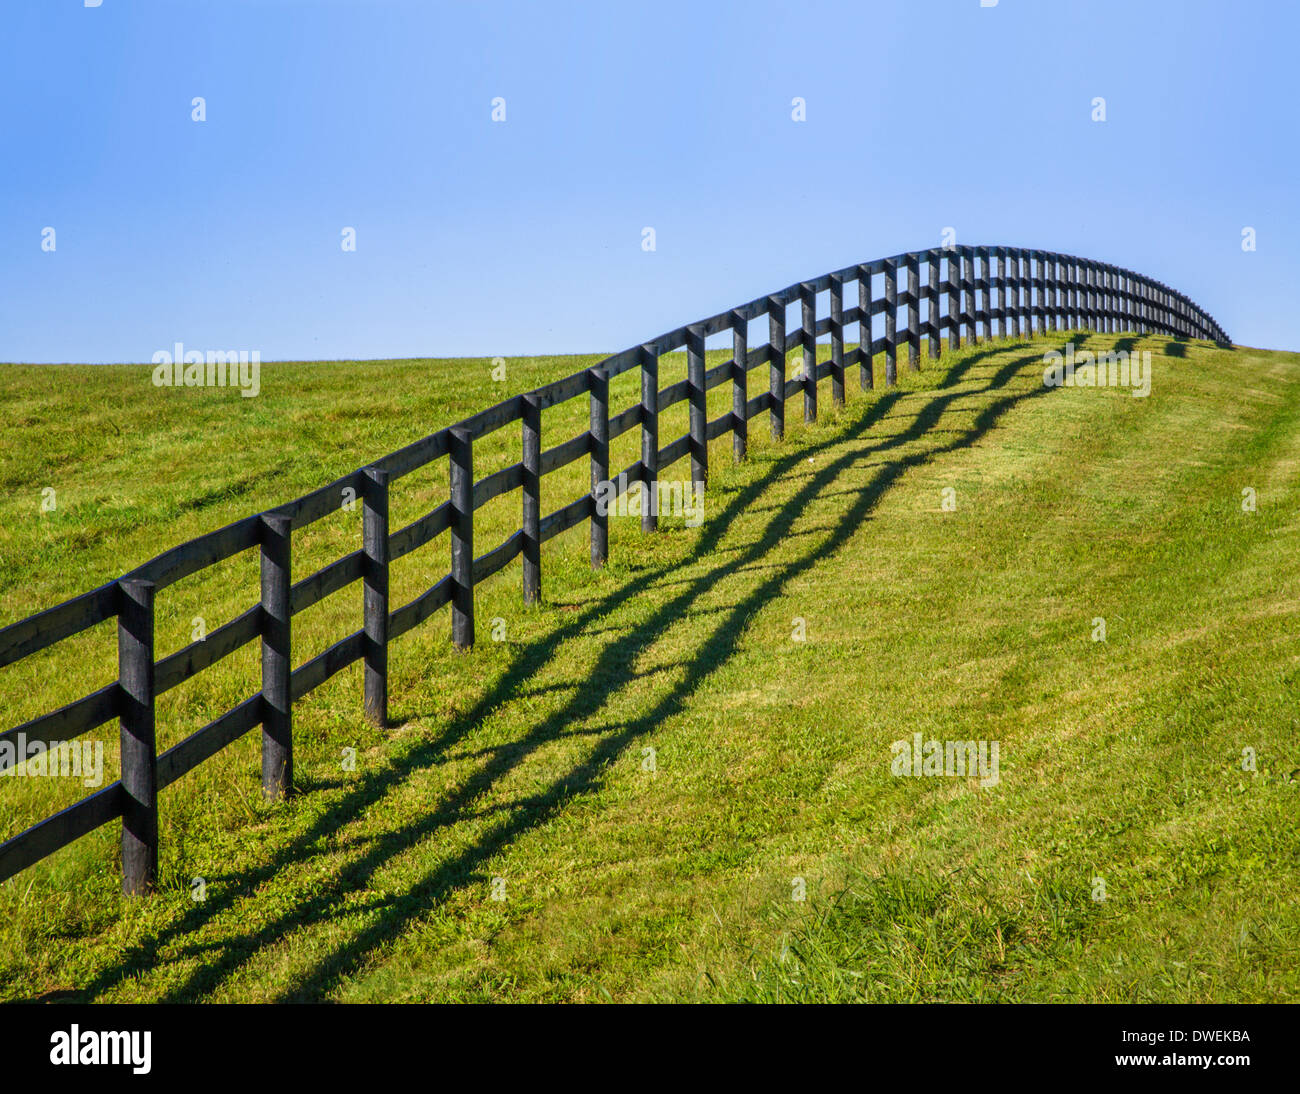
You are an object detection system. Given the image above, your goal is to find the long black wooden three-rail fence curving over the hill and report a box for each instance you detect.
[0,246,1230,894]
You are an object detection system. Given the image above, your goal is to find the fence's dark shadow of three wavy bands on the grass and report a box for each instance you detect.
[58,334,1087,1002]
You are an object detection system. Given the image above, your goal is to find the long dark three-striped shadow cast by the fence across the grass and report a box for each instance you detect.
[68,330,1066,1000]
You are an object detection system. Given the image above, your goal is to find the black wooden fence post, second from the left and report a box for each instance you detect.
[259,513,294,802]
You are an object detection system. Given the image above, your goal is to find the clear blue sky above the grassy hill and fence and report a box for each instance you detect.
[0,0,1300,361]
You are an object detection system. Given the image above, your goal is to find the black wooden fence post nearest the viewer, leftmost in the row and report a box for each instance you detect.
[117,581,159,897]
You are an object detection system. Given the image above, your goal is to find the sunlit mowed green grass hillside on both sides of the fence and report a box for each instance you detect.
[0,331,1300,1002]
